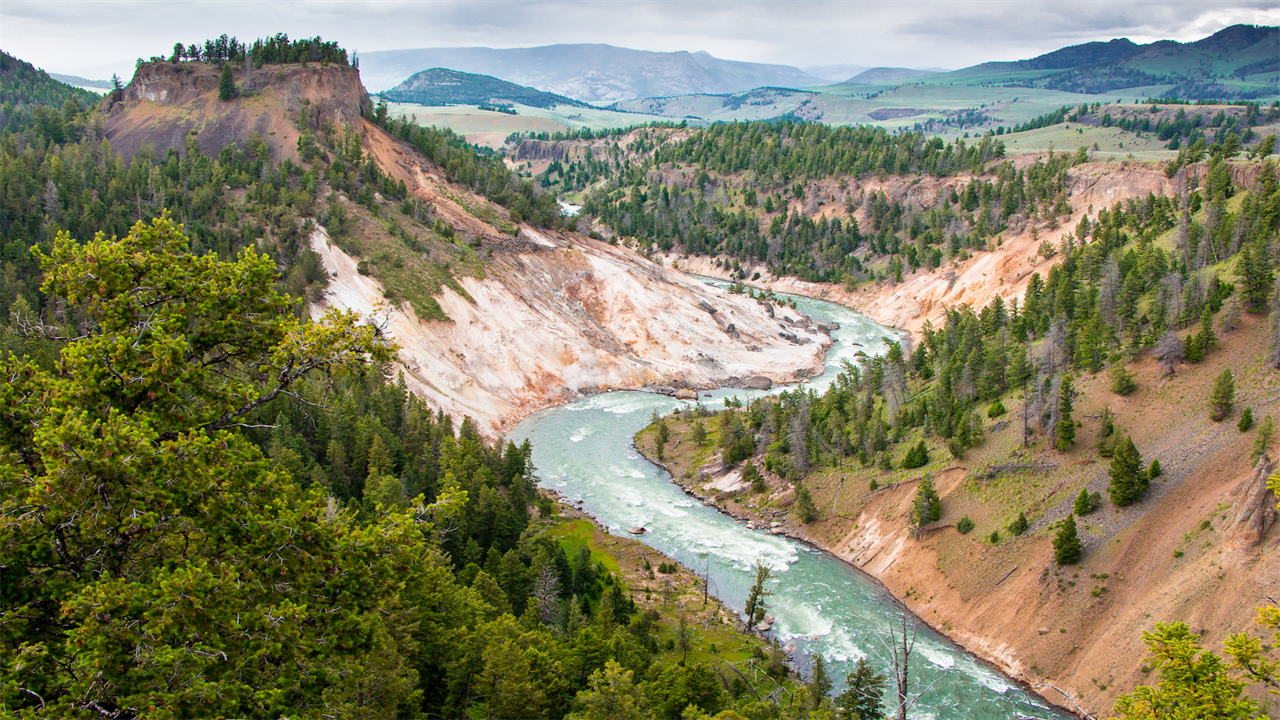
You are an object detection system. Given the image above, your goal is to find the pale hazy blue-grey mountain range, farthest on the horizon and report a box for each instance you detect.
[360,45,829,102]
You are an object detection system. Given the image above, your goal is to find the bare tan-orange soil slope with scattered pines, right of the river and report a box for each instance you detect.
[655,316,1280,716]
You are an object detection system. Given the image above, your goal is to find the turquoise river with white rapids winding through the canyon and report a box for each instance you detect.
[508,283,1069,720]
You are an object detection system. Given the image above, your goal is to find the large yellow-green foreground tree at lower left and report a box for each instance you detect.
[0,218,478,719]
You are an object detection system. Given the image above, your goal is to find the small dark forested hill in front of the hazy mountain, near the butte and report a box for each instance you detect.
[384,68,590,108]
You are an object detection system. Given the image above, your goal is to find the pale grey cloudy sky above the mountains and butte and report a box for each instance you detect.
[0,0,1280,78]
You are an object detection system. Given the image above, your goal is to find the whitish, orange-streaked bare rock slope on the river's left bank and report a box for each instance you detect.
[311,228,831,436]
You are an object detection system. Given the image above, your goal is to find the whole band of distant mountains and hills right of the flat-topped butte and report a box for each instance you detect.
[361,26,1280,122]
